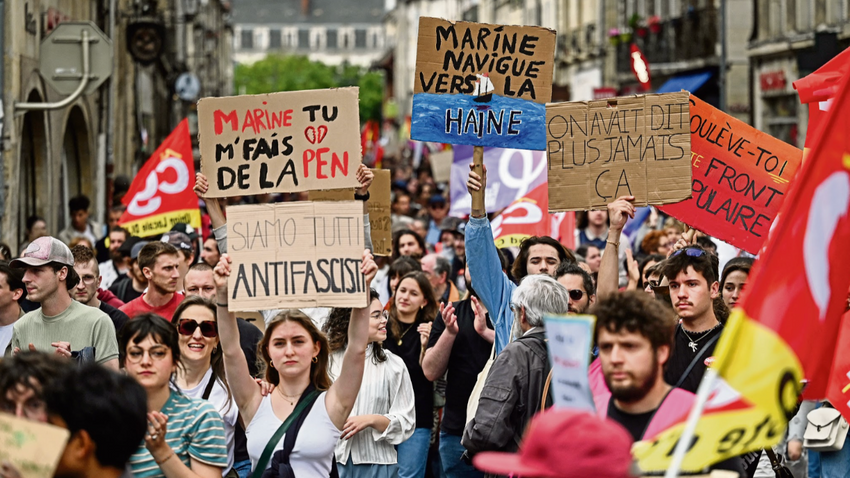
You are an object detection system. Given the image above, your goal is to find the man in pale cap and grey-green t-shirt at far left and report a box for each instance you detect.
[6,236,118,370]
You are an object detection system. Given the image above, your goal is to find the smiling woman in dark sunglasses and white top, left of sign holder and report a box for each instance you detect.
[171,295,239,477]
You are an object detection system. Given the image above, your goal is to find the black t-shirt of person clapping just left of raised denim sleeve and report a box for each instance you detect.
[428,299,493,435]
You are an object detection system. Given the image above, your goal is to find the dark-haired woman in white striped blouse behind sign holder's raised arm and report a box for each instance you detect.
[323,290,416,478]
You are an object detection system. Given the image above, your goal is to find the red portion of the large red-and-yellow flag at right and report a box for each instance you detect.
[743,63,850,399]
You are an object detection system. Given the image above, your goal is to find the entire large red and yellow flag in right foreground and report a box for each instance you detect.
[634,61,850,471]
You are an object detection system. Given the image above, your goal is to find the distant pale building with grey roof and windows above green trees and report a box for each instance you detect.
[229,0,385,67]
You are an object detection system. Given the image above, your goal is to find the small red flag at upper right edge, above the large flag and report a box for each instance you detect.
[793,48,850,149]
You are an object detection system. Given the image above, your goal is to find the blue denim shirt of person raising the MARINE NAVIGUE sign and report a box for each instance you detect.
[465,217,516,354]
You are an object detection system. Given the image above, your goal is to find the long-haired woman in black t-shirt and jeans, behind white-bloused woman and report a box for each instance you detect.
[384,272,439,478]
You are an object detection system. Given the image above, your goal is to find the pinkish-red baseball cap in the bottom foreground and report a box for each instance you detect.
[473,409,632,478]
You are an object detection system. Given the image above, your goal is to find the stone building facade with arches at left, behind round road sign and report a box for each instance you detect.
[0,0,232,248]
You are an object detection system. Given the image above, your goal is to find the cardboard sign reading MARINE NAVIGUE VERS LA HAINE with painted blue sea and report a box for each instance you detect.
[410,17,555,150]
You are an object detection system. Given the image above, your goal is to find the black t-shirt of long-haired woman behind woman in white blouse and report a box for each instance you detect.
[384,322,434,430]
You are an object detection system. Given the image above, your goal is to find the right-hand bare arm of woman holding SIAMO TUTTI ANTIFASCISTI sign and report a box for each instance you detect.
[324,250,378,430]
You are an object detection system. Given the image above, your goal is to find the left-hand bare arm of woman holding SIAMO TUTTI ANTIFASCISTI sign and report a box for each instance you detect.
[214,254,263,423]
